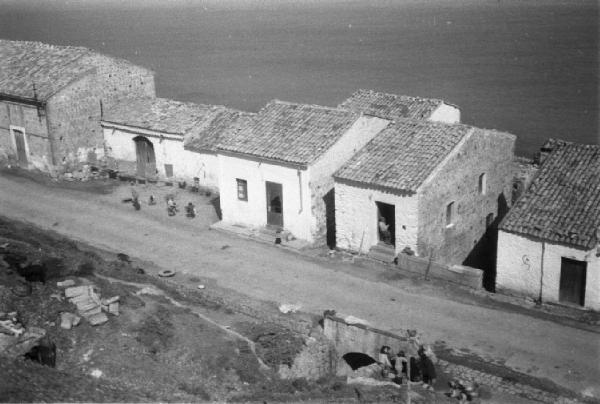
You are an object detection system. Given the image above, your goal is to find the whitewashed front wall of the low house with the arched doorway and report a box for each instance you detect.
[104,127,218,187]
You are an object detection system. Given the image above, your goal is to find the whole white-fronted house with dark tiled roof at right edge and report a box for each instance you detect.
[496,140,600,310]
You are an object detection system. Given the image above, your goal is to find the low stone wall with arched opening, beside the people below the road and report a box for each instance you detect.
[323,315,420,374]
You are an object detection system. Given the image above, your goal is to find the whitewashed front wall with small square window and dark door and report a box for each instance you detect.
[218,154,313,242]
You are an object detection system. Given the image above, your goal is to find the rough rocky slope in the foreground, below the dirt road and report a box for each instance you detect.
[0,219,444,402]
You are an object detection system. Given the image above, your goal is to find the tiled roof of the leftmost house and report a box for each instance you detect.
[0,39,94,101]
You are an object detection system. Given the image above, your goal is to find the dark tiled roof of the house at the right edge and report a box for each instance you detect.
[500,140,600,249]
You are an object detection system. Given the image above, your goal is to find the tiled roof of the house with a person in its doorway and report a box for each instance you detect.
[334,119,475,192]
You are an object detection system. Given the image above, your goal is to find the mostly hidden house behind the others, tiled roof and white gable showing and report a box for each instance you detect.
[338,90,460,123]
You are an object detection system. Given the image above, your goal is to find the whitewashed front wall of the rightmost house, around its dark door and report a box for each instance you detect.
[496,231,600,310]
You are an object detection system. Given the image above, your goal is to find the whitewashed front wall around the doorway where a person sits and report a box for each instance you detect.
[335,181,419,253]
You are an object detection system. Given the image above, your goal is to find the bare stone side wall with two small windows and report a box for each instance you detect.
[418,129,515,264]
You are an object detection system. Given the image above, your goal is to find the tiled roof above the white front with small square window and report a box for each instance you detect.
[218,100,360,164]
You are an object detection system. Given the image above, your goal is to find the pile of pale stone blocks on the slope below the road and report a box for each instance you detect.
[57,280,119,330]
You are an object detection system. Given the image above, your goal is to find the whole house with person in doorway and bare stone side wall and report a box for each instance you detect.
[334,119,516,264]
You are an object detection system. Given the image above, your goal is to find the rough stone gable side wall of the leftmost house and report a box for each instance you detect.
[48,54,155,164]
